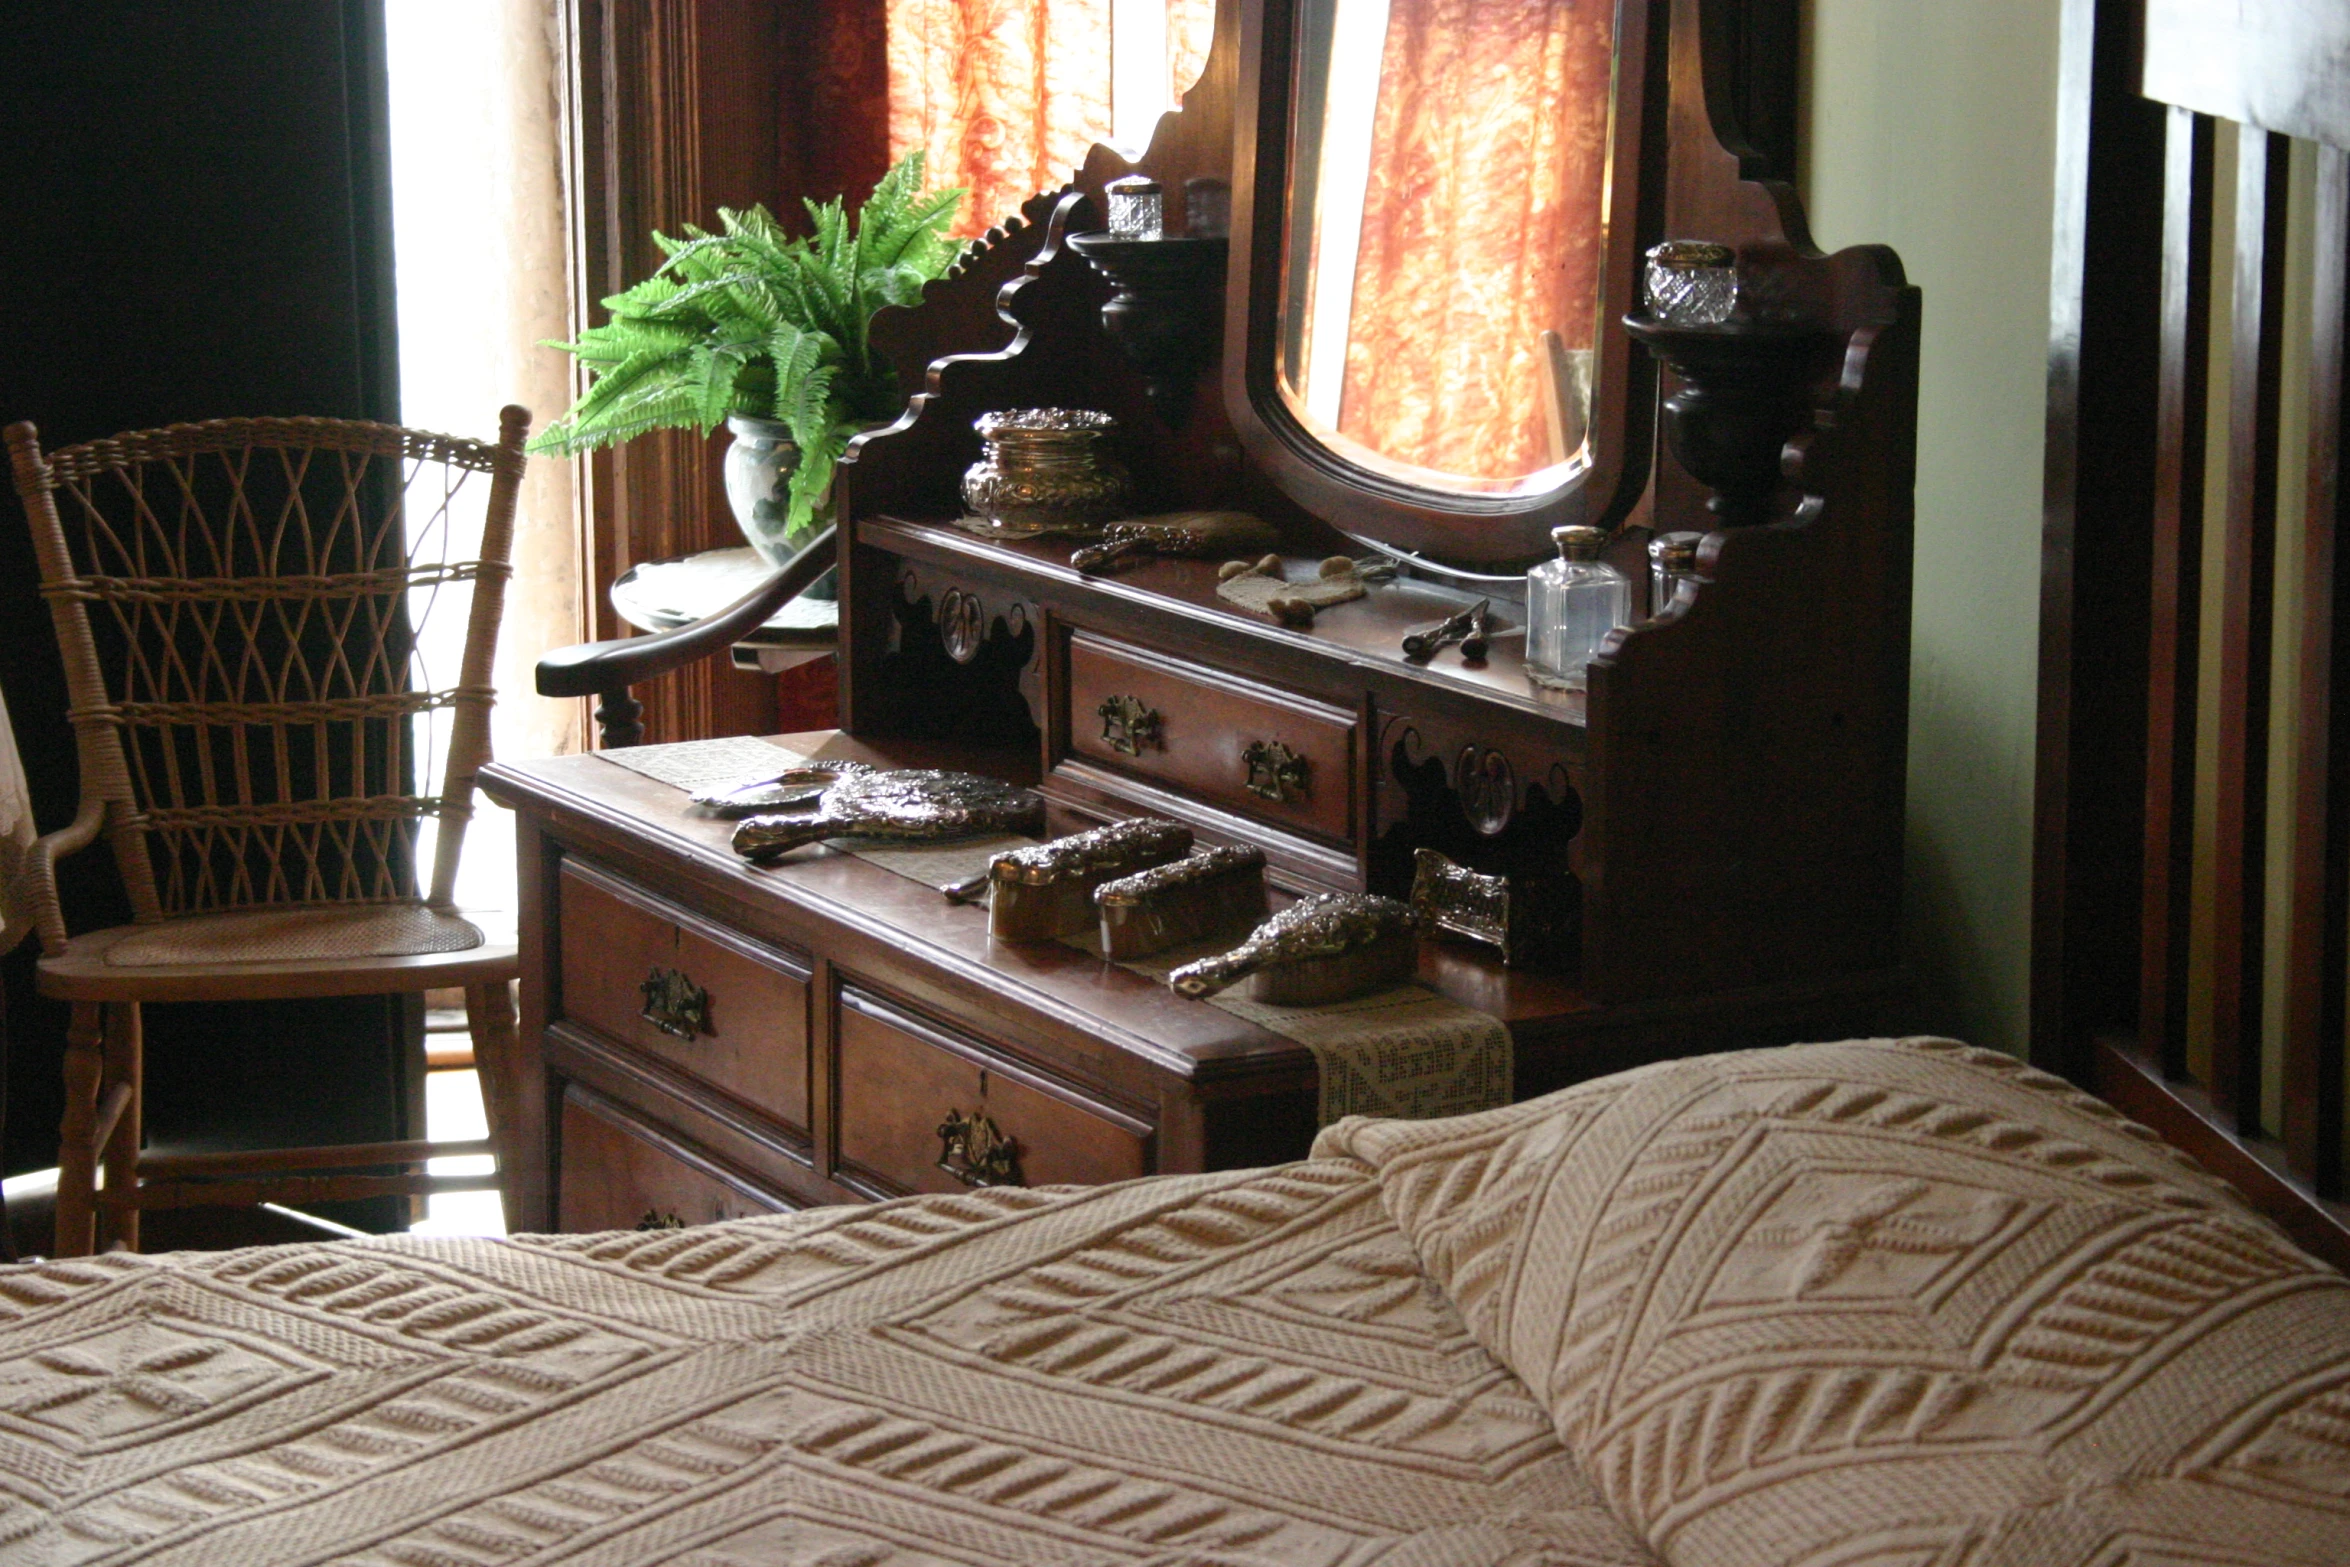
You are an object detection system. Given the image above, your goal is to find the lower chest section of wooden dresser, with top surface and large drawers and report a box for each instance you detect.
[482,733,1887,1231]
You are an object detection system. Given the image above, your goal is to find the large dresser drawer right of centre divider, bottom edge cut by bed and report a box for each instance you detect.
[834,984,1152,1191]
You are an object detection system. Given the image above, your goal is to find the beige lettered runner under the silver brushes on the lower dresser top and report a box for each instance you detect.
[597,738,1516,1125]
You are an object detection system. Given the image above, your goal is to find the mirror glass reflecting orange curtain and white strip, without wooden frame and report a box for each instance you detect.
[1283,0,1614,482]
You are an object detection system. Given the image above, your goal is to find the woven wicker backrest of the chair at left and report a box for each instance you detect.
[7,406,529,921]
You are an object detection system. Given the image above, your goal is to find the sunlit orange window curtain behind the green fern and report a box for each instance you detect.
[886,0,1215,237]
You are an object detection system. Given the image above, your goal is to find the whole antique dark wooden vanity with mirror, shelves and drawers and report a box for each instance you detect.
[486,0,1920,1229]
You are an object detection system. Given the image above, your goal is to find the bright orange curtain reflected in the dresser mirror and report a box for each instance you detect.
[1340,0,1614,479]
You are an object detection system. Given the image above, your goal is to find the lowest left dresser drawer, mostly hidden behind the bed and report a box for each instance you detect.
[555,1083,792,1236]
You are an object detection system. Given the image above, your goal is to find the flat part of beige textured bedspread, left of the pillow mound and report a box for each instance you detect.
[0,1161,1652,1567]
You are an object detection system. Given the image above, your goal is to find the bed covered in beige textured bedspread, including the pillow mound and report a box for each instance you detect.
[0,1041,2350,1567]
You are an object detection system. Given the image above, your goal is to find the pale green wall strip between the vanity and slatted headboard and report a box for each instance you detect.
[1802,0,2059,1052]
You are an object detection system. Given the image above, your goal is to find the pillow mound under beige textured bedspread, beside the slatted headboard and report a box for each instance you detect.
[1316,1038,2350,1567]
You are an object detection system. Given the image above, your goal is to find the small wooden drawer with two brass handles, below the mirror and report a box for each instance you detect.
[1067,632,1358,843]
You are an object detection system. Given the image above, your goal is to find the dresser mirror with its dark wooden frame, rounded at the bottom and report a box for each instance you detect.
[1236,0,1643,564]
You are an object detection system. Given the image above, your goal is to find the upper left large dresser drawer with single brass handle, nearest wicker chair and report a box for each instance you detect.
[557,860,808,1137]
